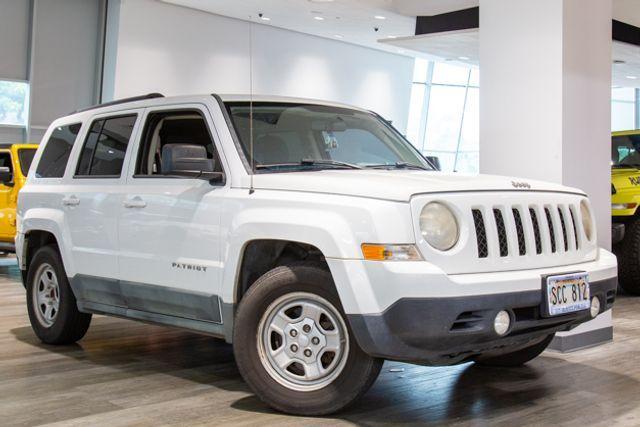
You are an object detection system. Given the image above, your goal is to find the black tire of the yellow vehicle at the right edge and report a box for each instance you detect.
[615,220,640,295]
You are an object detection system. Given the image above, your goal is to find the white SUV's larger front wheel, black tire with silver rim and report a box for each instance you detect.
[233,263,383,416]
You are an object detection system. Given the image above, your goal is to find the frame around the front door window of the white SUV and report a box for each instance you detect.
[130,104,228,187]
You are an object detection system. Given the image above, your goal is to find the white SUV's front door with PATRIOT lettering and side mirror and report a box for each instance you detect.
[119,105,226,323]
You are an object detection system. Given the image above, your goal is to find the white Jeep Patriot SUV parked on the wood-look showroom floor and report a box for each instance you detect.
[16,94,617,415]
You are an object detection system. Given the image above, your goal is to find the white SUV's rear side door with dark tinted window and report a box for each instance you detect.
[62,110,143,306]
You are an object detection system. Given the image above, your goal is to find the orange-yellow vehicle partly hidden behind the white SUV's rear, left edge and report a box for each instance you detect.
[0,144,38,252]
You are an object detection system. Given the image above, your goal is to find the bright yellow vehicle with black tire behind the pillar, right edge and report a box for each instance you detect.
[611,129,640,295]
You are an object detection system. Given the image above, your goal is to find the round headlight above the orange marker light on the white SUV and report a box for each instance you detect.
[420,202,459,251]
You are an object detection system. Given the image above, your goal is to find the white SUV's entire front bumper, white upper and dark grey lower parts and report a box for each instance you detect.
[327,250,617,365]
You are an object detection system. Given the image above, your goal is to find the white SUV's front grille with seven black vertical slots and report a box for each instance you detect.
[471,204,579,258]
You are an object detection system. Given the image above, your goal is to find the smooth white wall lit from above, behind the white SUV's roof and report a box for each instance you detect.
[104,0,413,131]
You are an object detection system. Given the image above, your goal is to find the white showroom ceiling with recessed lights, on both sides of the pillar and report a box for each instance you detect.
[161,0,640,87]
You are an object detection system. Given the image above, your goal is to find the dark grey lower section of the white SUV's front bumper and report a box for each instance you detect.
[348,277,618,365]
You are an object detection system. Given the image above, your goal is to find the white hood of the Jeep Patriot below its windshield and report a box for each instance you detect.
[248,169,584,202]
